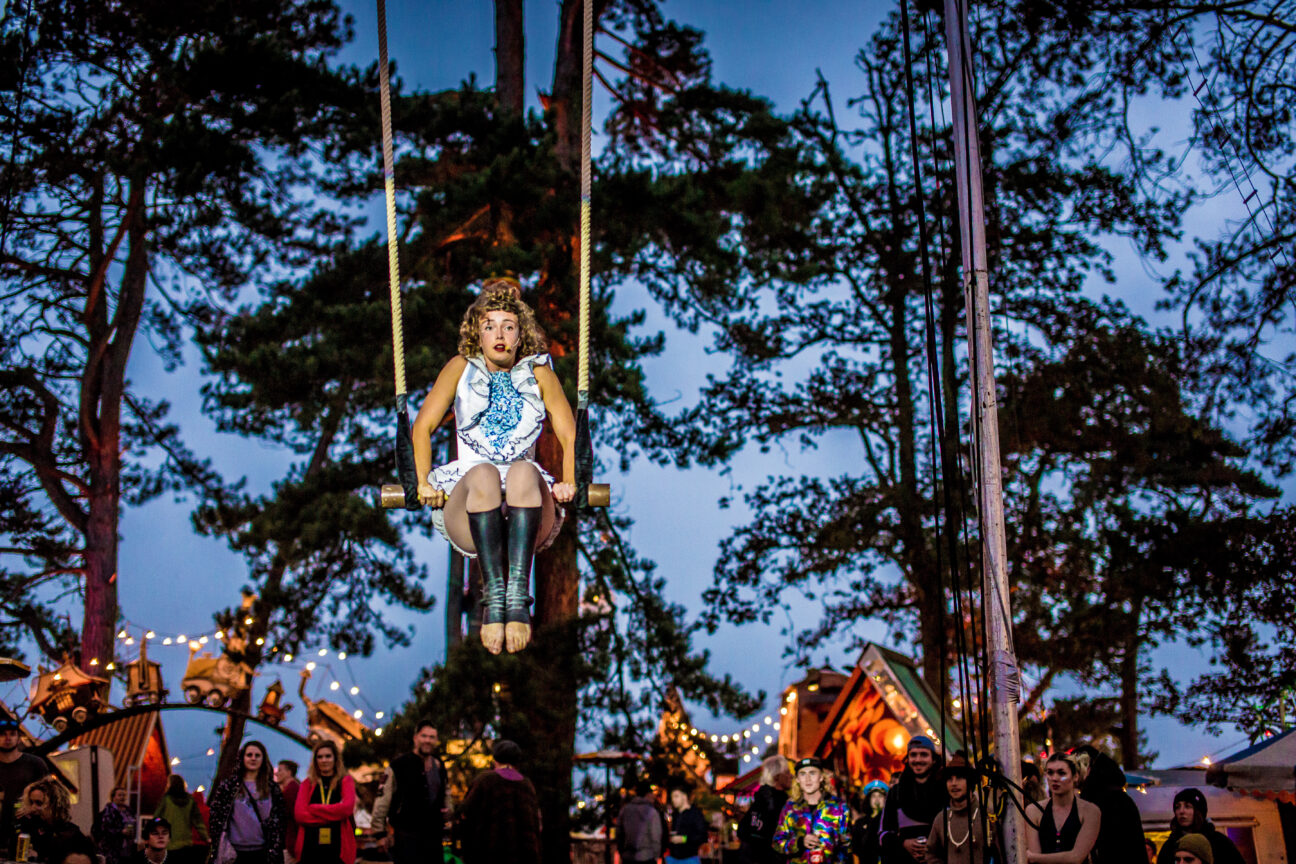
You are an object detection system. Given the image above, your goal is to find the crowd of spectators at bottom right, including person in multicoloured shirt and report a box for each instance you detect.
[617,736,1244,864]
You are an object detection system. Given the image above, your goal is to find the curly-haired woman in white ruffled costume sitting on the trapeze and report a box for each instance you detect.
[412,279,575,654]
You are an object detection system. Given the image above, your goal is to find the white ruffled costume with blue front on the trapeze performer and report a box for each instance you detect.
[428,354,564,557]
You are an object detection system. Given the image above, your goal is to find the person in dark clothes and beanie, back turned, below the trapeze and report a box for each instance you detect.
[459,741,540,864]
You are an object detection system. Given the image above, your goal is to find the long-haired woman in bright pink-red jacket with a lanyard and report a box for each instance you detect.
[293,741,355,864]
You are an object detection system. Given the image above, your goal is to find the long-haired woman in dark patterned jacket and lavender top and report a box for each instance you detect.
[209,741,284,864]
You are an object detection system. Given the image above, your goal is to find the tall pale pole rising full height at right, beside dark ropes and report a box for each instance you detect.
[945,0,1026,864]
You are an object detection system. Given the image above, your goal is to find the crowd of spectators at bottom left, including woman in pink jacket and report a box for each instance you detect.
[0,715,540,864]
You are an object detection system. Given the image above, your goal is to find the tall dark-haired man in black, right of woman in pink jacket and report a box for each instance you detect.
[372,720,447,864]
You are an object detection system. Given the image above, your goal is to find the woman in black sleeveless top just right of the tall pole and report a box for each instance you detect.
[1026,753,1099,864]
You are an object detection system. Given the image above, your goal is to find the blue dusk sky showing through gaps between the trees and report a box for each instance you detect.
[0,0,1244,786]
